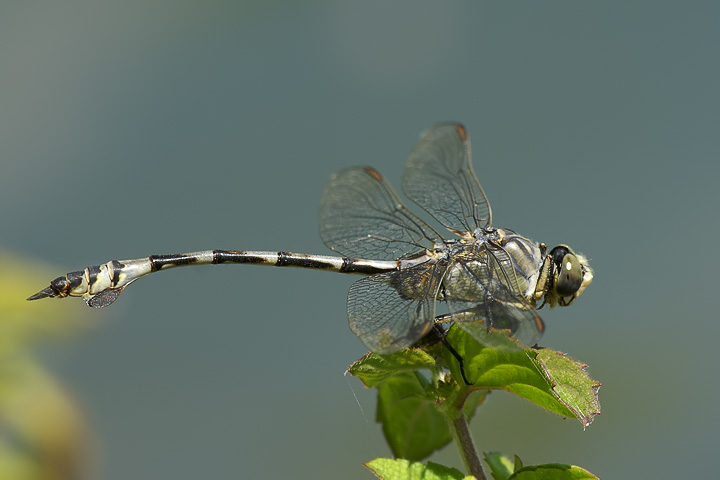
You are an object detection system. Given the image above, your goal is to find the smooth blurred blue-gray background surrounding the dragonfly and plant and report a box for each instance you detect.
[0,0,720,480]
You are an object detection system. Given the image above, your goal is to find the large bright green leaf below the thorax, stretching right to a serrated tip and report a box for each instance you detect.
[446,328,600,427]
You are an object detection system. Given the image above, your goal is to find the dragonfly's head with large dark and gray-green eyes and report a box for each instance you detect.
[545,245,593,307]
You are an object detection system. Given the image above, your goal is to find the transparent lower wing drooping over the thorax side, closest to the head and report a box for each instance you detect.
[443,248,545,350]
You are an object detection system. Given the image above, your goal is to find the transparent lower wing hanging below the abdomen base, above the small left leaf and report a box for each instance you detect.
[347,263,443,353]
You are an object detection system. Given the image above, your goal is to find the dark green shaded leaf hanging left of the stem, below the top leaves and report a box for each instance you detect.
[377,372,452,460]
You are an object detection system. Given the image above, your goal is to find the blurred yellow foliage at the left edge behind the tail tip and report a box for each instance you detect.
[0,251,93,480]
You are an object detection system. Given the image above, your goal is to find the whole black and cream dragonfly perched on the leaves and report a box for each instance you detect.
[28,123,593,354]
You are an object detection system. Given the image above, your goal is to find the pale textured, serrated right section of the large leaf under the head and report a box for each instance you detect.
[536,349,600,427]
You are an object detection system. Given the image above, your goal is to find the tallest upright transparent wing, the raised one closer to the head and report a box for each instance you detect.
[403,123,492,232]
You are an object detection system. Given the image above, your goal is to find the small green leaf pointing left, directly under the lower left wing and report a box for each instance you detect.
[345,348,436,387]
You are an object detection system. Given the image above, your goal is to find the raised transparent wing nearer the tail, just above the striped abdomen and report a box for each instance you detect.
[320,167,440,260]
